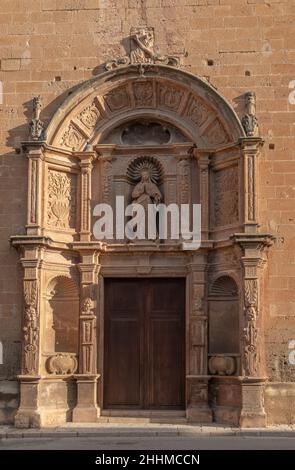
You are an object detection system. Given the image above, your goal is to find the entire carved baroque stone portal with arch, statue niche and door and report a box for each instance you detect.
[12,53,272,426]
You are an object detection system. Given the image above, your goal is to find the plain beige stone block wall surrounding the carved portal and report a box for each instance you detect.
[0,0,295,421]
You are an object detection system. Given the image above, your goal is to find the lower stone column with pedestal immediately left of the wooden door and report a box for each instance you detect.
[73,248,100,422]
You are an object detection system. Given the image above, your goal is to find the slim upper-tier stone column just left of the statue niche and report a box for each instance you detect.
[76,151,96,241]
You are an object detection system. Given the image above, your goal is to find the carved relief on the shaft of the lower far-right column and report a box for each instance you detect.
[243,279,259,376]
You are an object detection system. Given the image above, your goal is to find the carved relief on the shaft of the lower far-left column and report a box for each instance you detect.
[23,280,39,375]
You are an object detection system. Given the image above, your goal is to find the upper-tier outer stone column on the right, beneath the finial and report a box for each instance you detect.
[240,137,263,233]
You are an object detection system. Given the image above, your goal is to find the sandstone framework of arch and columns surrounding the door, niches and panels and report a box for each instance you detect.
[11,64,273,427]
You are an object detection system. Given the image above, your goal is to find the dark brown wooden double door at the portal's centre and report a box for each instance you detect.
[104,278,185,409]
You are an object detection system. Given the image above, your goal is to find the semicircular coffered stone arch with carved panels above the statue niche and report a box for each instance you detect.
[47,65,245,151]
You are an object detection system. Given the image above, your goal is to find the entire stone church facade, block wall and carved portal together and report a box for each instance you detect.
[0,0,295,427]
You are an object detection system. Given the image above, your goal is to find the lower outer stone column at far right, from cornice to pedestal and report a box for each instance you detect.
[234,234,273,427]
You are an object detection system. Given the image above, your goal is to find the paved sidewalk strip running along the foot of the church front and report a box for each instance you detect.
[0,423,295,440]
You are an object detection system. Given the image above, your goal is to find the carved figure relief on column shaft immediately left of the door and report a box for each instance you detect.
[79,297,96,374]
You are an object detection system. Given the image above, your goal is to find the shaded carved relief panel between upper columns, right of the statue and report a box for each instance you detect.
[214,166,239,226]
